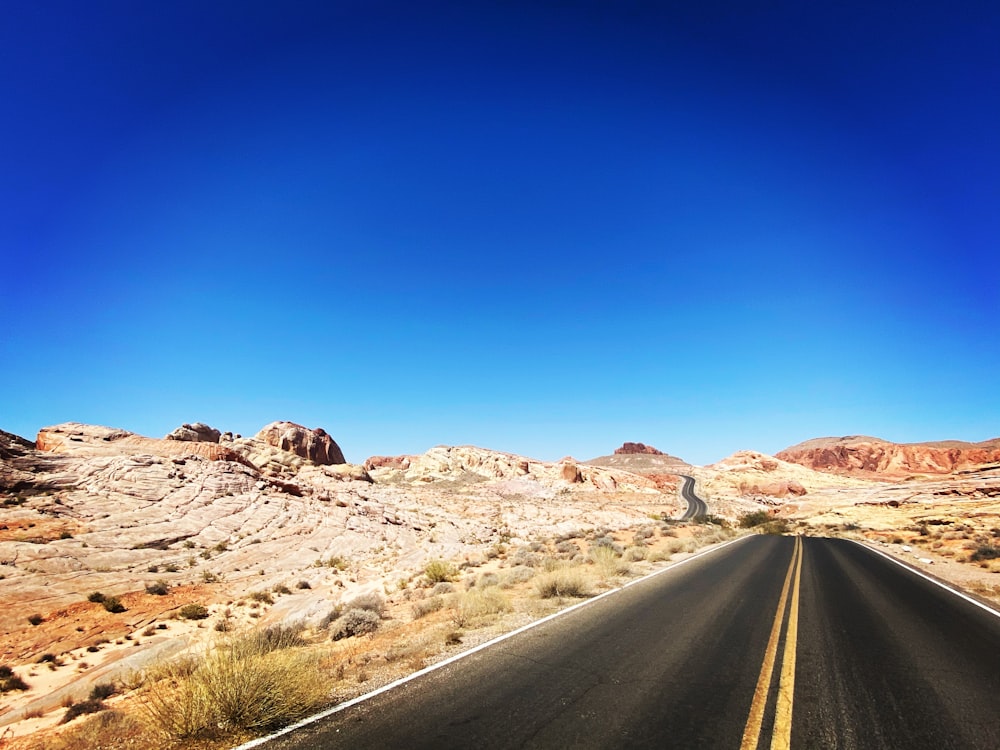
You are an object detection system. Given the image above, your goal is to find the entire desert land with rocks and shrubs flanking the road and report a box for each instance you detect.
[0,422,1000,748]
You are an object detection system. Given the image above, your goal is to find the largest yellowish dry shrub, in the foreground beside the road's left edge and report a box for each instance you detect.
[141,636,329,739]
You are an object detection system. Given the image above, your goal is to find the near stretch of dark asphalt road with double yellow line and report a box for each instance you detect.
[254,536,1000,750]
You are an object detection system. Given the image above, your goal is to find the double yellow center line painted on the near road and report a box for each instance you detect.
[740,537,802,750]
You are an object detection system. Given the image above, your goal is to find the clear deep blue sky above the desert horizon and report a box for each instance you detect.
[0,0,1000,463]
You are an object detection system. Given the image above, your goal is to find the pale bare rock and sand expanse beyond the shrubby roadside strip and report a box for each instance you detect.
[0,422,1000,746]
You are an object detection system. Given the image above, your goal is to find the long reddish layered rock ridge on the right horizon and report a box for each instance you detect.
[776,436,1000,477]
